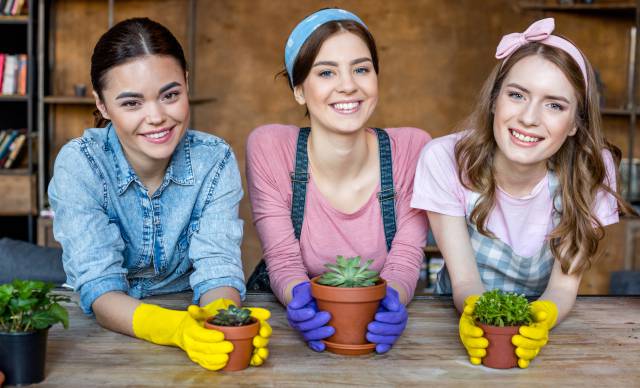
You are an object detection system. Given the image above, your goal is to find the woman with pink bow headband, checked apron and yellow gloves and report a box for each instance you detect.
[411,19,633,368]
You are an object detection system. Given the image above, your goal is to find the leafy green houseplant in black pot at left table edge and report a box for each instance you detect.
[0,279,69,385]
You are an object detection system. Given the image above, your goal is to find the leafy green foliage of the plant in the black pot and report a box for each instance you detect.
[0,279,69,333]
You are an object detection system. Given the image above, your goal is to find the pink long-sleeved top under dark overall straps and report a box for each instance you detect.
[247,124,430,301]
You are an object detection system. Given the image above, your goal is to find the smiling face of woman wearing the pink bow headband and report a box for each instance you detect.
[493,55,577,173]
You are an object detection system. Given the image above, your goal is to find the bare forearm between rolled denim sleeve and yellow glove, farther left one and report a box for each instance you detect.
[92,291,142,337]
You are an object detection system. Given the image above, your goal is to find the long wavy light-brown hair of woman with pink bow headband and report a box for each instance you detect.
[455,43,636,274]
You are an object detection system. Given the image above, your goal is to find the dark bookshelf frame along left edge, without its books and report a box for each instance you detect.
[0,2,38,242]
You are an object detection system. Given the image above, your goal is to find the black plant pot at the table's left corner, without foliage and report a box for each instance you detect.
[0,329,49,385]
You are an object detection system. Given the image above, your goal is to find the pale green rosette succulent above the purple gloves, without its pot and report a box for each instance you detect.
[318,256,380,288]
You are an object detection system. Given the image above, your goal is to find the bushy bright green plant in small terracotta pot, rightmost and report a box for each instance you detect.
[473,289,533,369]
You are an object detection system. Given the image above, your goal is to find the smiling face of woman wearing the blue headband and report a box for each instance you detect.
[294,31,378,134]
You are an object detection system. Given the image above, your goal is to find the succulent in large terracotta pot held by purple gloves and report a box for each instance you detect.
[311,256,387,355]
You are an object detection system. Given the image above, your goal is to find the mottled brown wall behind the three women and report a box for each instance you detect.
[48,0,640,280]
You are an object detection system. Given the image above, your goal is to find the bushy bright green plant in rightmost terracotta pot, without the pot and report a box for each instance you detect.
[473,289,533,327]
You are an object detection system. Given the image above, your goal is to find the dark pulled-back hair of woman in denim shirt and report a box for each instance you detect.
[91,18,187,128]
